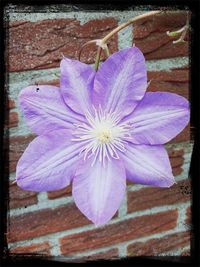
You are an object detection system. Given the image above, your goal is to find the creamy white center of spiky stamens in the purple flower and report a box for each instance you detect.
[73,108,130,164]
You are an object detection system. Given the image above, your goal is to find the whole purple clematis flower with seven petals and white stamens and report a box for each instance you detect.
[16,47,189,225]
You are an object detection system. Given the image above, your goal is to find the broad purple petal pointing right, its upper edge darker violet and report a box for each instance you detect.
[126,92,190,145]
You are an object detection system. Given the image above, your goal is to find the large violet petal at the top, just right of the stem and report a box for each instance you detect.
[93,47,147,117]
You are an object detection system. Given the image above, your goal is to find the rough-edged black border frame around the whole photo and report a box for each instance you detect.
[0,0,200,266]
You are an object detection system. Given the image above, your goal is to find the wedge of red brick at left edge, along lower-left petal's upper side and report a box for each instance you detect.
[9,135,34,172]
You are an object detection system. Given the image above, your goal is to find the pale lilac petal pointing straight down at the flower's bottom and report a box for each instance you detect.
[72,159,126,225]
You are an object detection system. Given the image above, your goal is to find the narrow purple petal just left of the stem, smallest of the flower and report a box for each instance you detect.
[60,58,95,114]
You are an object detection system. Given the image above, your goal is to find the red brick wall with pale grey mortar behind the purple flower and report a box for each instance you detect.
[5,6,193,261]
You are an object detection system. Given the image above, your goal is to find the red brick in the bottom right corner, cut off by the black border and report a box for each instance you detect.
[127,232,190,256]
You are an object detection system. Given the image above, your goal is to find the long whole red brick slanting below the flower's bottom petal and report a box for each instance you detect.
[60,210,178,255]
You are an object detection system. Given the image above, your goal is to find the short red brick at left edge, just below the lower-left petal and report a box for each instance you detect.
[9,182,37,209]
